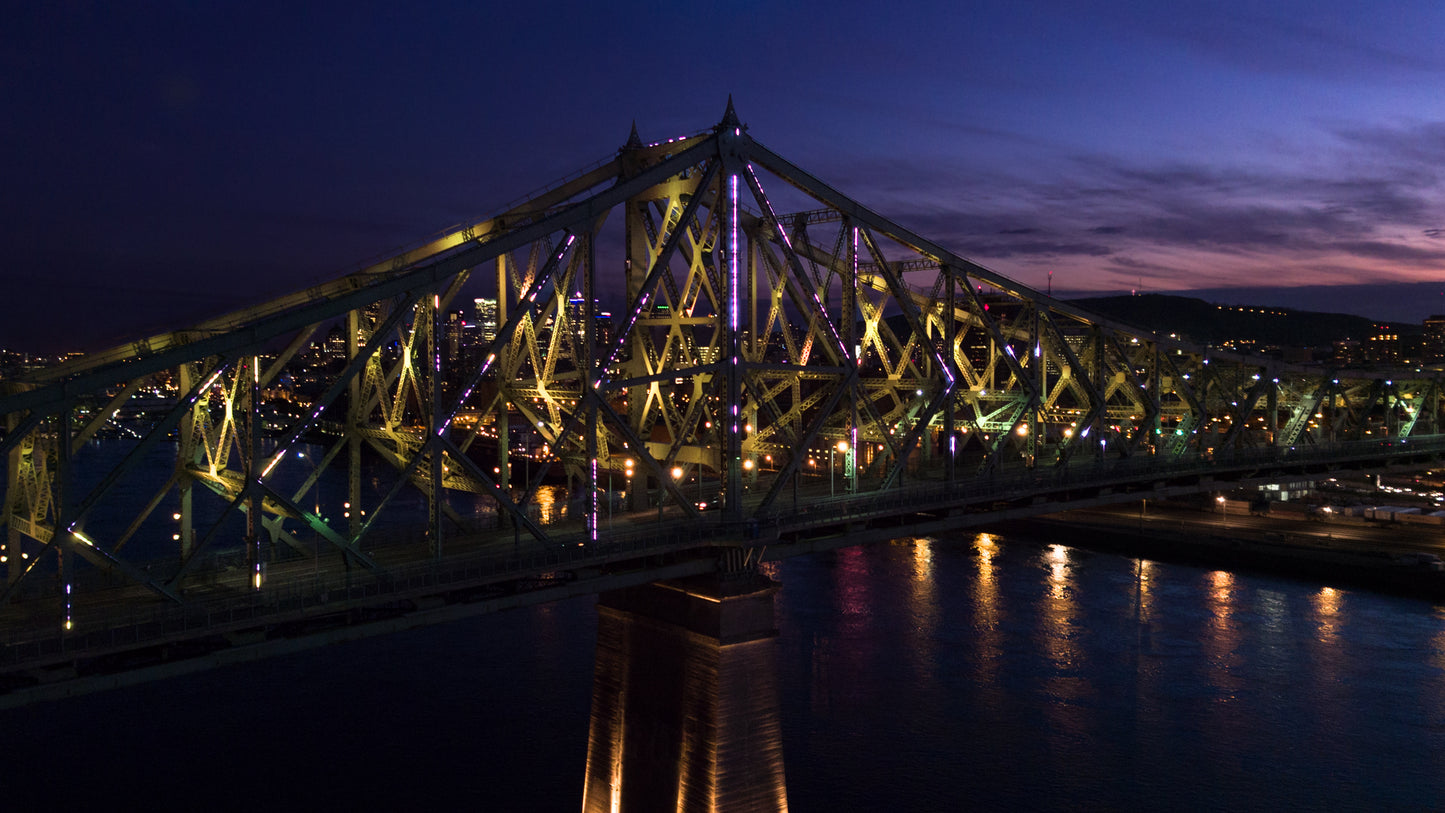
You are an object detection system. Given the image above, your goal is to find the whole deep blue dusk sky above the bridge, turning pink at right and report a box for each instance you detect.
[0,0,1445,351]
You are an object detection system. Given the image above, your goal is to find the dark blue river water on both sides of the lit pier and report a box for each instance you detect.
[0,533,1445,812]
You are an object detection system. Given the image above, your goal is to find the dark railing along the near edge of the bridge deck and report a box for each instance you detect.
[0,436,1445,667]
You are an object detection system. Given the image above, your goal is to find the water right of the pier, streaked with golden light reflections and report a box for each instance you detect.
[777,534,1445,810]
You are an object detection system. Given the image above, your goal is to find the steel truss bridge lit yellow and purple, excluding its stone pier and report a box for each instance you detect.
[0,101,1445,698]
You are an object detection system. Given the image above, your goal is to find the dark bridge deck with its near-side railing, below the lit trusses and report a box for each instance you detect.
[0,436,1445,708]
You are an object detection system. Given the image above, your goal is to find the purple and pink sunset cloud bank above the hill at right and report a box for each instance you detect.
[768,112,1445,307]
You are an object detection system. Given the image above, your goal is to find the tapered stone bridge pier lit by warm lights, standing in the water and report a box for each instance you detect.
[582,573,788,812]
